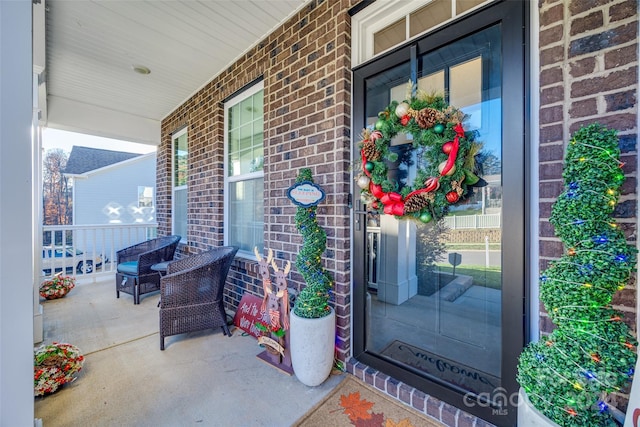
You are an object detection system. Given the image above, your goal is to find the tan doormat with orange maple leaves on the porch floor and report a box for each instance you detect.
[293,374,444,427]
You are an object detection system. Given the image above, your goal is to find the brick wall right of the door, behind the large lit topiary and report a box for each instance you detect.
[539,0,638,408]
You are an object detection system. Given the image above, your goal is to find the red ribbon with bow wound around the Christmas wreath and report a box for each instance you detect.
[360,123,464,216]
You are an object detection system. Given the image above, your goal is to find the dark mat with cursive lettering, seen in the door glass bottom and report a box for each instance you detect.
[381,340,500,394]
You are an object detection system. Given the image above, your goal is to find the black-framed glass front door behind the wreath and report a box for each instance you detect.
[353,2,526,425]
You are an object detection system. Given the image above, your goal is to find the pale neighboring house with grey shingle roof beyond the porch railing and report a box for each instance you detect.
[64,146,156,225]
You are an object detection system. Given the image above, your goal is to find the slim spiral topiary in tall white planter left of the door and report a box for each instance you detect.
[293,169,333,319]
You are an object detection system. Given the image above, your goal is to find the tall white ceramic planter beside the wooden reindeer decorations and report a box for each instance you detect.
[289,309,336,387]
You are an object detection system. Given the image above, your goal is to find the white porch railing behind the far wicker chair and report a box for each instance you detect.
[39,223,158,279]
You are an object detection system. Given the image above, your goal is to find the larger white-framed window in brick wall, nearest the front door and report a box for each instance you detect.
[224,82,264,256]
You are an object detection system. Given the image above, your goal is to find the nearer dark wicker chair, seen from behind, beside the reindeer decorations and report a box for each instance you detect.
[160,246,238,350]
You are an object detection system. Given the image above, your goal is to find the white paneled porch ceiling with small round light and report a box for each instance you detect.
[42,0,307,144]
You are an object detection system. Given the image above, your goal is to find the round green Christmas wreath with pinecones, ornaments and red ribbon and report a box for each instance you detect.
[356,92,481,223]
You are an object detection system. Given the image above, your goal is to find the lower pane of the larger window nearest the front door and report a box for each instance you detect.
[228,178,264,252]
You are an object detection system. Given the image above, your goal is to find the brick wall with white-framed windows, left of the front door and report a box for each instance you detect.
[157,0,357,360]
